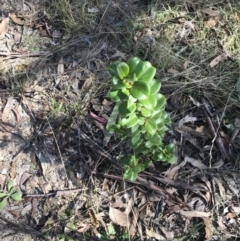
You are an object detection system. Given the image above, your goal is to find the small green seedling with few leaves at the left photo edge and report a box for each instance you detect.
[0,180,22,210]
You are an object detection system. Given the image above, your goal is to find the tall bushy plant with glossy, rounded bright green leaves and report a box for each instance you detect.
[107,57,175,181]
